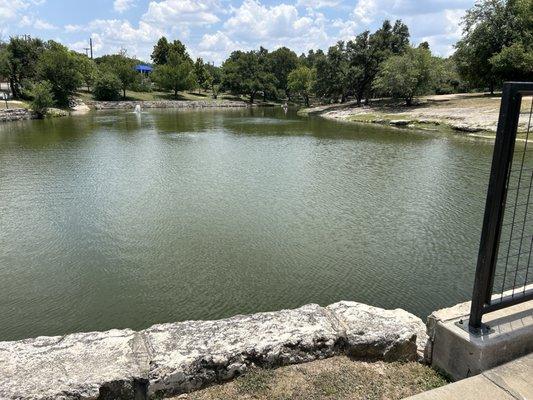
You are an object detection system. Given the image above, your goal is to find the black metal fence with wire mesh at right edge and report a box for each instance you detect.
[469,82,533,333]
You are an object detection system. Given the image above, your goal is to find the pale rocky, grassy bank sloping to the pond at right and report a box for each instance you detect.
[300,93,531,138]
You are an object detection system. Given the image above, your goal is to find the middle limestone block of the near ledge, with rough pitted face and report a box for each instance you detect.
[142,304,341,395]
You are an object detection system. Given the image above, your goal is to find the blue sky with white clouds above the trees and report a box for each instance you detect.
[0,0,474,64]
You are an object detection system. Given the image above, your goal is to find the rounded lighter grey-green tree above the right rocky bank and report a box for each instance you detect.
[373,48,435,106]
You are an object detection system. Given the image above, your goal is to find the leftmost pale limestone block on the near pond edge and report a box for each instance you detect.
[0,329,148,400]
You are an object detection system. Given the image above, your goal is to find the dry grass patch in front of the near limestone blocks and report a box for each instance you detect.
[174,356,447,400]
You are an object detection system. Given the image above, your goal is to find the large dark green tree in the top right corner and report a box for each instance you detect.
[454,0,533,93]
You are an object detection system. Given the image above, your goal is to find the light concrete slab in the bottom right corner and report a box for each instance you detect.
[405,353,533,400]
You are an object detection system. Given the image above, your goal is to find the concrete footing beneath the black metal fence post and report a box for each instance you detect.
[426,301,533,381]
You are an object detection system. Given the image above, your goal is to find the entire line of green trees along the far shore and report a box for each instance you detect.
[0,0,533,115]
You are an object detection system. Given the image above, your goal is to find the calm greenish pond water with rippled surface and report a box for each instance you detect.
[0,108,492,340]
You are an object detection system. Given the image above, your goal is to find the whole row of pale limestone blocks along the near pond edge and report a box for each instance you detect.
[0,302,426,400]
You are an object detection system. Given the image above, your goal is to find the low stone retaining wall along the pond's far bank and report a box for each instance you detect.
[86,100,248,110]
